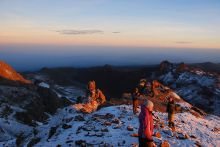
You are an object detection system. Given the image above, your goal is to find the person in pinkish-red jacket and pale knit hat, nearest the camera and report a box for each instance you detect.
[138,100,154,147]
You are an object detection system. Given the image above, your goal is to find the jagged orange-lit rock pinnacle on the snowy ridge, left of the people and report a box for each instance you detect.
[73,81,106,113]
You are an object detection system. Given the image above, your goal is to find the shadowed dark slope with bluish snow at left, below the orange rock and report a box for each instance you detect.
[0,68,70,146]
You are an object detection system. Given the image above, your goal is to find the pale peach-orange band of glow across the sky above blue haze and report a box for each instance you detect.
[0,27,220,49]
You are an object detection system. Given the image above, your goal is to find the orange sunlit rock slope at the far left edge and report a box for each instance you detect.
[0,61,31,84]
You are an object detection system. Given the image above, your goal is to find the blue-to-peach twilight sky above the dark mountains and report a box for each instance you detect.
[0,0,220,70]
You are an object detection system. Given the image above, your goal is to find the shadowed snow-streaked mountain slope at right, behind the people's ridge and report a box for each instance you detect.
[158,62,220,116]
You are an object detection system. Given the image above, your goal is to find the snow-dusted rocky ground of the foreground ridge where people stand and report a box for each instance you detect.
[31,105,220,147]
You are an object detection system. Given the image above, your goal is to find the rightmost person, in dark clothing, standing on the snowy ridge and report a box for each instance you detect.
[167,96,176,128]
